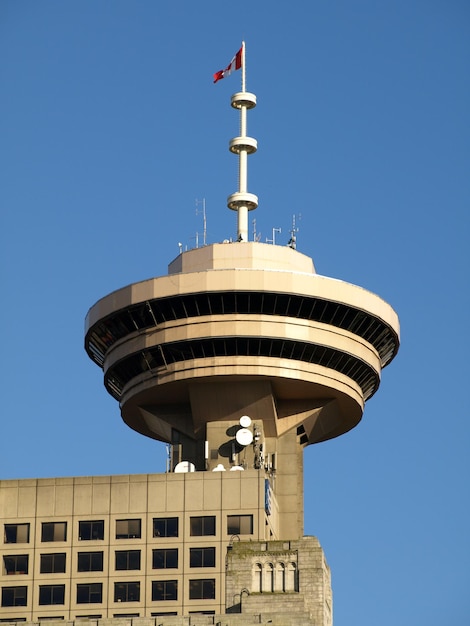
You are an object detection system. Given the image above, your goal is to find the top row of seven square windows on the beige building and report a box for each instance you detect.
[4,515,253,543]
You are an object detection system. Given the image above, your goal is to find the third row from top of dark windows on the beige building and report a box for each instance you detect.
[2,578,215,607]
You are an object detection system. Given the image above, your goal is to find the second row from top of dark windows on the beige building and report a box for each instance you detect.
[3,547,215,575]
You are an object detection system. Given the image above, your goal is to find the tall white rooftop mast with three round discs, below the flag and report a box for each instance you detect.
[227,41,258,242]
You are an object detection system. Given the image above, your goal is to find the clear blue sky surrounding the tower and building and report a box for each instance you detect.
[0,0,470,626]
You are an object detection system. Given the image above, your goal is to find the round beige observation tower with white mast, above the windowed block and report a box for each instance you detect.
[85,46,399,539]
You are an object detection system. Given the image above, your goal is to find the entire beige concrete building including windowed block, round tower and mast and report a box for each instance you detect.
[0,46,399,626]
